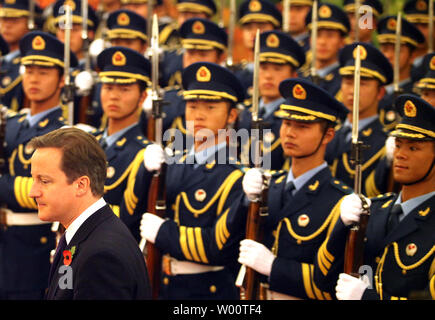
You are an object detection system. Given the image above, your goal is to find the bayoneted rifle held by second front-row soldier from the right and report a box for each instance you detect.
[236,29,270,300]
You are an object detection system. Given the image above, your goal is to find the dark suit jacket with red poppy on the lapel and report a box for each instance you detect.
[46,205,150,300]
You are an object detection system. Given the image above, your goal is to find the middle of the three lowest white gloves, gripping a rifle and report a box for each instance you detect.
[238,239,276,276]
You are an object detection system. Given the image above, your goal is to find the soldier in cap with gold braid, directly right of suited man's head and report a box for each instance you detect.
[96,46,150,240]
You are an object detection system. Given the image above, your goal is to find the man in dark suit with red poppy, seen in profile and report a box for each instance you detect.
[30,128,150,300]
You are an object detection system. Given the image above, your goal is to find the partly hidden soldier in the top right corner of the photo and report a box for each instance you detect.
[403,0,435,73]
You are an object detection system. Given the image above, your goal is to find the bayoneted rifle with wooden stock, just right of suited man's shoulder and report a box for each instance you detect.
[139,14,167,300]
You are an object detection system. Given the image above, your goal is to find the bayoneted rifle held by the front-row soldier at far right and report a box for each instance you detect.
[344,45,370,277]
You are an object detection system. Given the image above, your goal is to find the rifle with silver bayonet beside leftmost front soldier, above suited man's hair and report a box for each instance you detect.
[64,4,74,126]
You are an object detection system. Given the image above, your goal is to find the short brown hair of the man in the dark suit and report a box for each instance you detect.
[30,128,107,196]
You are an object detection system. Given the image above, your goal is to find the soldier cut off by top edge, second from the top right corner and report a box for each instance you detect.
[343,0,384,44]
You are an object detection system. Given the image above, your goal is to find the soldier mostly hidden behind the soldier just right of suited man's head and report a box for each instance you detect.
[90,9,149,128]
